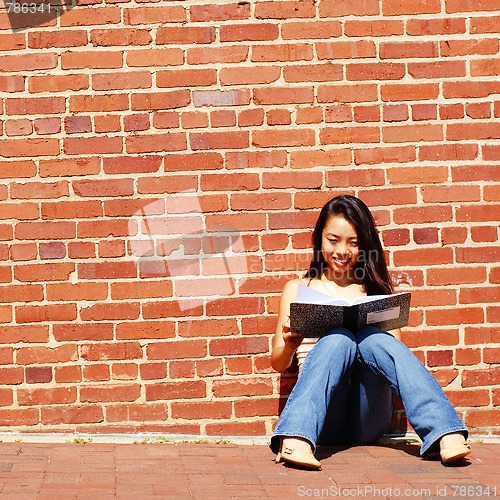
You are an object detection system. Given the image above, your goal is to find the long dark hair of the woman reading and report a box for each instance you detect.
[306,195,394,295]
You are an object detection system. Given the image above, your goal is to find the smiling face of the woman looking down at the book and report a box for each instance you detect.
[321,215,359,282]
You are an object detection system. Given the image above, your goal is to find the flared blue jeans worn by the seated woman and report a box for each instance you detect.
[270,326,468,455]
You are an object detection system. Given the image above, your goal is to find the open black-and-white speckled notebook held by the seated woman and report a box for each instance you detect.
[290,285,411,337]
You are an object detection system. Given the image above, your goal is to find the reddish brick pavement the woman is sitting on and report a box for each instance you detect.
[0,442,500,500]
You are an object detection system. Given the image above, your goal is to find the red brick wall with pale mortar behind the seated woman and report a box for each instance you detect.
[0,0,500,436]
